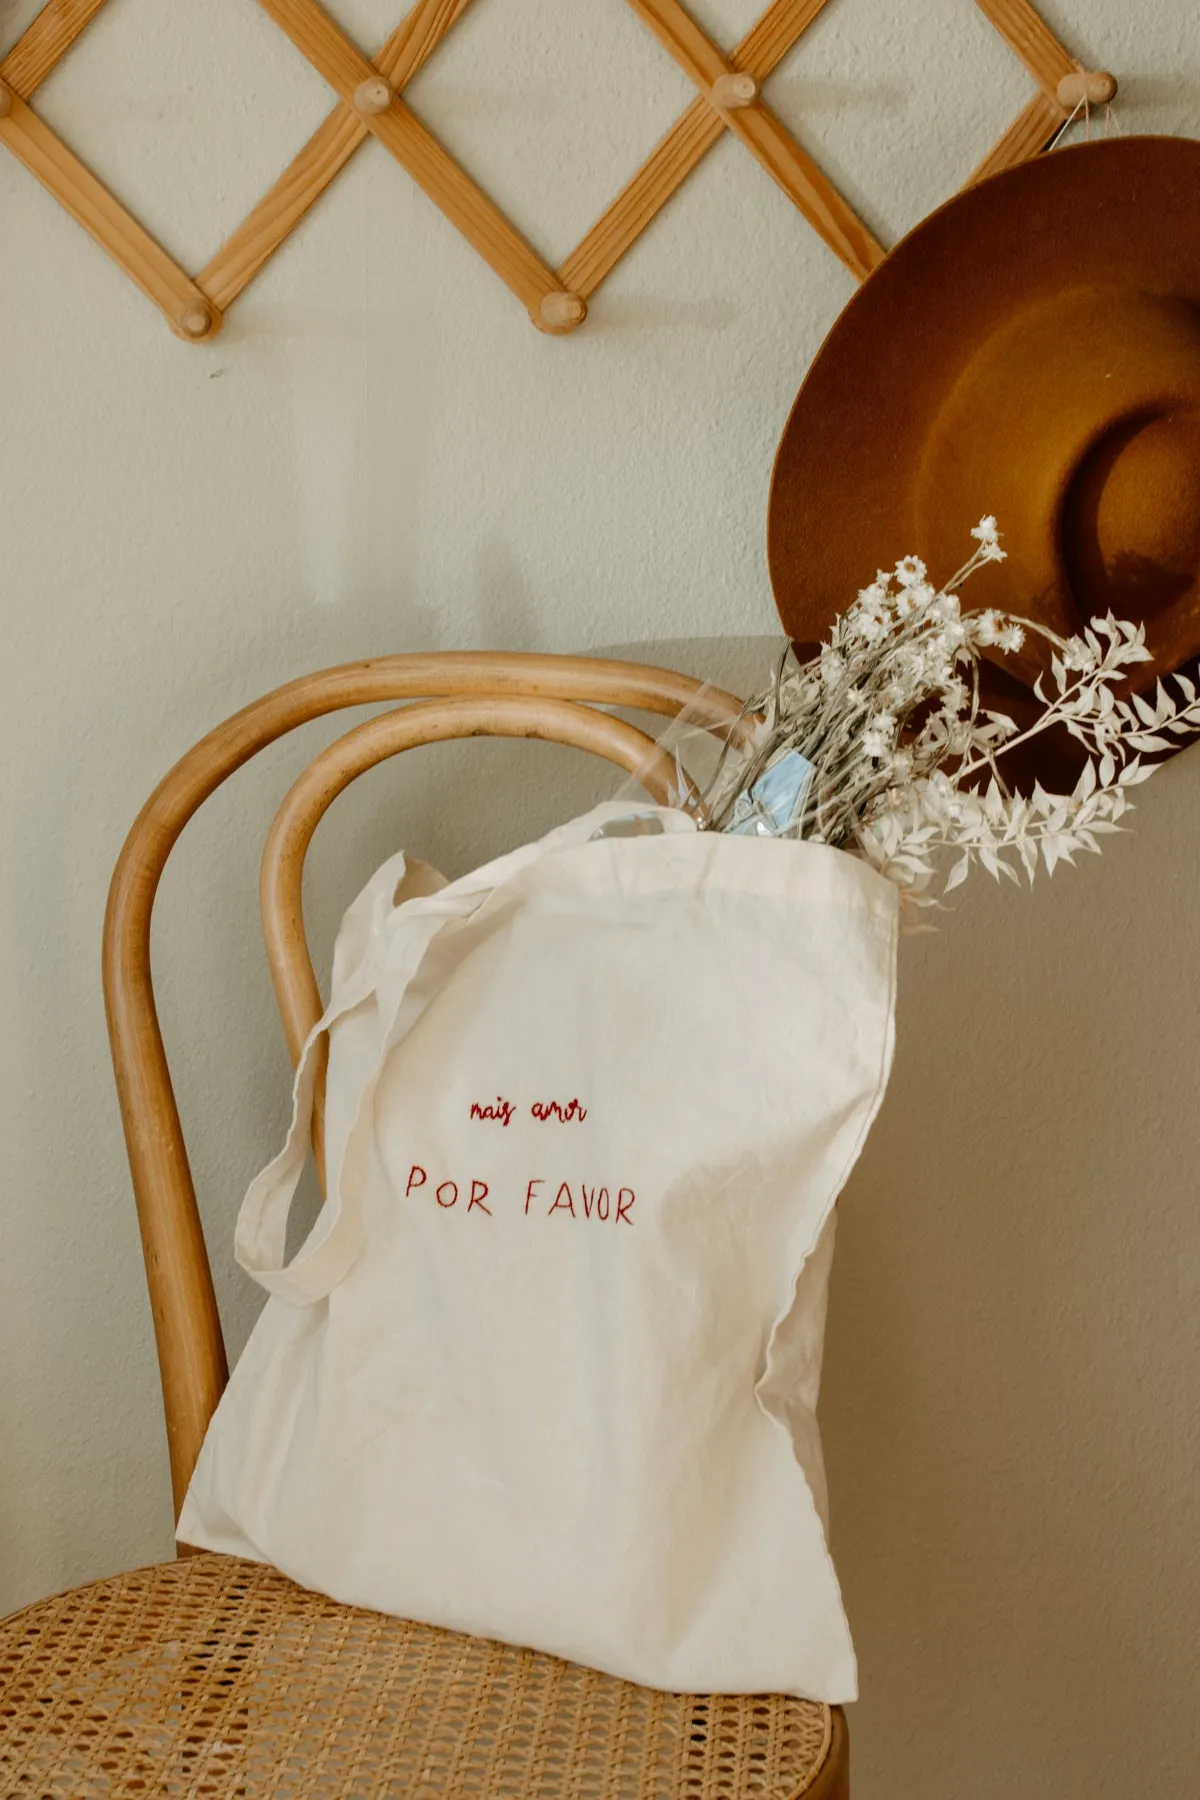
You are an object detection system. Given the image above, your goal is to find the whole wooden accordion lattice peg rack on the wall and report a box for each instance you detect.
[0,0,1117,344]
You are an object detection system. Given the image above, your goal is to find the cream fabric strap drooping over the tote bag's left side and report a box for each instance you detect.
[234,803,694,1307]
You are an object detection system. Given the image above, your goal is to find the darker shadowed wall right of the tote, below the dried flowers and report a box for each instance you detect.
[615,639,1200,1800]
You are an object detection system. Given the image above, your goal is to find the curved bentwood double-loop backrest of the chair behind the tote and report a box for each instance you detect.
[104,652,741,1514]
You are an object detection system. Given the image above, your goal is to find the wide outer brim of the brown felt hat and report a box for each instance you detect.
[766,137,1200,644]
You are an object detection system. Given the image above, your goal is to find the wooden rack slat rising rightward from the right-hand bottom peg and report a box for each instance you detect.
[558,0,828,299]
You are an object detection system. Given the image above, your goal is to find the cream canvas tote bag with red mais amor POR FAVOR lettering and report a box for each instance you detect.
[178,805,898,1701]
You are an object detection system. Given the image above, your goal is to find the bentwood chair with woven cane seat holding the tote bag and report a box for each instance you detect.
[0,653,849,1800]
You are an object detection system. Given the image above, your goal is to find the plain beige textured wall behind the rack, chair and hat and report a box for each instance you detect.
[0,0,1200,1800]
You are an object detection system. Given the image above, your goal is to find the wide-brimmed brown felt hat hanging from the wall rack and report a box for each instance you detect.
[766,137,1200,686]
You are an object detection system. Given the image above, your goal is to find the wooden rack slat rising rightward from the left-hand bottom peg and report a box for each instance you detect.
[196,0,471,308]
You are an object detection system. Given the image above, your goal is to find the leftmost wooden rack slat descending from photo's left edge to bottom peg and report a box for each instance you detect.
[0,95,221,337]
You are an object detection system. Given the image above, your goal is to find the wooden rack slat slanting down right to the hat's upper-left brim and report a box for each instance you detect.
[628,0,883,281]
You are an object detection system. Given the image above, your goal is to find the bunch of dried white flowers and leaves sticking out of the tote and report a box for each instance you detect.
[698,518,1200,905]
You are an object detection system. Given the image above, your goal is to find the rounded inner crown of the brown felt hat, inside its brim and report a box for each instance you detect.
[914,283,1200,680]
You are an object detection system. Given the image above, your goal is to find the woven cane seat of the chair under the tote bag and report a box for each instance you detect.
[0,1555,831,1800]
